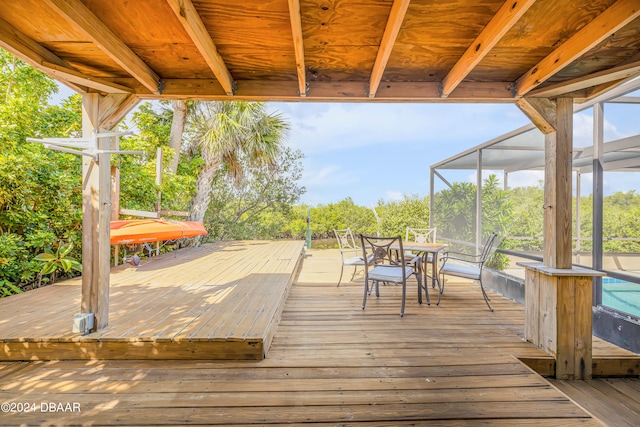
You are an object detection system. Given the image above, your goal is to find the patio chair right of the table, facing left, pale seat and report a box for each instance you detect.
[439,233,497,311]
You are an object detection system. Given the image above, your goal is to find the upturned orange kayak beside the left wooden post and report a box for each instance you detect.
[110,219,207,245]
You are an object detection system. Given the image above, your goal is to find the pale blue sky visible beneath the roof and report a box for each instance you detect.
[52,87,640,206]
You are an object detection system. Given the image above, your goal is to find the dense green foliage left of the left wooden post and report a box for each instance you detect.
[0,50,82,293]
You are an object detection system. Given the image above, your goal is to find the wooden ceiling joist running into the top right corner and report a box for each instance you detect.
[516,0,640,96]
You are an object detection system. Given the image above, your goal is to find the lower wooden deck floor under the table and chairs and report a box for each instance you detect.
[0,250,640,427]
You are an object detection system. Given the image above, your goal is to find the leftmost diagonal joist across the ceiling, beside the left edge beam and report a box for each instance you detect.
[44,0,162,93]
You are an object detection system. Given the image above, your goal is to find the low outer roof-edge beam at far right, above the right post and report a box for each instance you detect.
[527,61,640,98]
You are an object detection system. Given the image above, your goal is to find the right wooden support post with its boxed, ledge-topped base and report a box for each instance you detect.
[520,98,600,380]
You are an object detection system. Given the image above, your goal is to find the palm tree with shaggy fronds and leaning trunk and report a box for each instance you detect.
[188,101,289,221]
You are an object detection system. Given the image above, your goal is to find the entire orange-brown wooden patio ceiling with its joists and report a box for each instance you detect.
[0,0,640,102]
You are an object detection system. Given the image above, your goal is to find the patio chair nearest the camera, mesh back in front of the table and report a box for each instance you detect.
[359,234,428,316]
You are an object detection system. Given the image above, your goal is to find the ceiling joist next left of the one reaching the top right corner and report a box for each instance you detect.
[442,0,536,98]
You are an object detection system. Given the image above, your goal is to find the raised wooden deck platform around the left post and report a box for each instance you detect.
[0,241,304,360]
